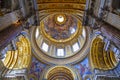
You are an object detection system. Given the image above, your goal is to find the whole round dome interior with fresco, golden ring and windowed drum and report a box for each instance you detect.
[33,13,86,58]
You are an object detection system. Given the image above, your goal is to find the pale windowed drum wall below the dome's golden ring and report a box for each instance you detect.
[36,28,86,58]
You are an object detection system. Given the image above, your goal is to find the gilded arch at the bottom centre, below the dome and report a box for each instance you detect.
[44,66,76,80]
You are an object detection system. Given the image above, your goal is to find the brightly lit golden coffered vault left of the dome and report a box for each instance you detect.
[3,36,31,69]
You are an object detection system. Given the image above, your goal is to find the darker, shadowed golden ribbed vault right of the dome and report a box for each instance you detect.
[90,37,118,70]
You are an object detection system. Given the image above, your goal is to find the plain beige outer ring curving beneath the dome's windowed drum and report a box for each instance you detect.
[31,13,91,64]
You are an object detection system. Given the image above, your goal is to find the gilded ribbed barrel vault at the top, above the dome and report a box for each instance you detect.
[37,0,86,20]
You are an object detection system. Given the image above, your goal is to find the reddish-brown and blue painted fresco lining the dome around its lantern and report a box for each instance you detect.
[44,15,77,40]
